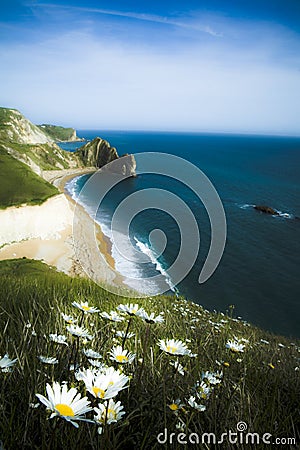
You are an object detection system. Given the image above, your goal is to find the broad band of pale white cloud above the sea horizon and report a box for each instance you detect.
[0,16,300,134]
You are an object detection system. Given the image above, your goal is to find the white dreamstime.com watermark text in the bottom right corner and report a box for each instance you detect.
[156,422,296,446]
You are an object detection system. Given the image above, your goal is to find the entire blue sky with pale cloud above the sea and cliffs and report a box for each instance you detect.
[0,0,300,135]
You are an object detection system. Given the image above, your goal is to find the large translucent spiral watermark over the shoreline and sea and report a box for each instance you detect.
[73,152,226,297]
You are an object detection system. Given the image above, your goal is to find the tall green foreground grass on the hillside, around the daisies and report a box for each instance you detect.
[0,259,300,450]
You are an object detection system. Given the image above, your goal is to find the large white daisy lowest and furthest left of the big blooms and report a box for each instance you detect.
[36,382,93,428]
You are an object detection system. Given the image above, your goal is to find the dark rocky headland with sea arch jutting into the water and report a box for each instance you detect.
[76,137,136,176]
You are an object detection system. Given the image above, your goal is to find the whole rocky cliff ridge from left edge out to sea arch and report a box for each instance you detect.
[0,107,136,176]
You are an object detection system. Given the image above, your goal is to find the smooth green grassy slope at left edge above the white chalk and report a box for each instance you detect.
[0,145,59,208]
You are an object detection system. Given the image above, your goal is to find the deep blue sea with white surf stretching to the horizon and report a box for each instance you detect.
[64,130,300,337]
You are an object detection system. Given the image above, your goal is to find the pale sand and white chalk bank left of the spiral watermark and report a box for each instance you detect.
[0,169,122,288]
